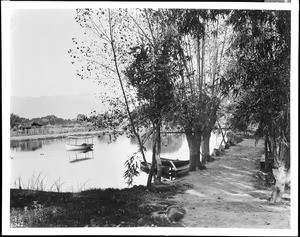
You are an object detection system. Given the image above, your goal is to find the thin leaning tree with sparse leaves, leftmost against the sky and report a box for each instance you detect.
[68,9,151,185]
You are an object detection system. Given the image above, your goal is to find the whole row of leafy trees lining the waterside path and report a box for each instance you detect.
[68,9,290,201]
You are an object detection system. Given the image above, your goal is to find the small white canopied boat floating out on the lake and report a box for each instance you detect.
[66,136,94,151]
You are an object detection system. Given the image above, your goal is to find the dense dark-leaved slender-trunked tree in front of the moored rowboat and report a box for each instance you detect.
[126,36,176,186]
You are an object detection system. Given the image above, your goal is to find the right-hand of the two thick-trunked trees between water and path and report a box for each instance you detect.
[202,10,232,163]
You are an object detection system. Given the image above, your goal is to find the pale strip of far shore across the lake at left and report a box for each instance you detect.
[10,130,109,141]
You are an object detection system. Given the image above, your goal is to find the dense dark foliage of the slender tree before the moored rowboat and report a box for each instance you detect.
[126,39,176,121]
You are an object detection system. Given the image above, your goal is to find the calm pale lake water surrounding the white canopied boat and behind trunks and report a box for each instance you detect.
[10,134,222,191]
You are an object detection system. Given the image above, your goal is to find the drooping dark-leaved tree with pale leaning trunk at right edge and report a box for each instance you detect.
[222,10,291,202]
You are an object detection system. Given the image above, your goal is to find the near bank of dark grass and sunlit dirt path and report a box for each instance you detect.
[10,138,291,229]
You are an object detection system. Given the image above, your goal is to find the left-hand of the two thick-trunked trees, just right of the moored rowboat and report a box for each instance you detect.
[164,9,206,171]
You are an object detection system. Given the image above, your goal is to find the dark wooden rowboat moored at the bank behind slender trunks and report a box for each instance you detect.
[140,158,190,177]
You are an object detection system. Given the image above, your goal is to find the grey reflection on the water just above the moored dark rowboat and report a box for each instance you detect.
[130,133,184,153]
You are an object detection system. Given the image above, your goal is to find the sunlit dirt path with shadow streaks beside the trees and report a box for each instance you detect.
[173,139,290,229]
